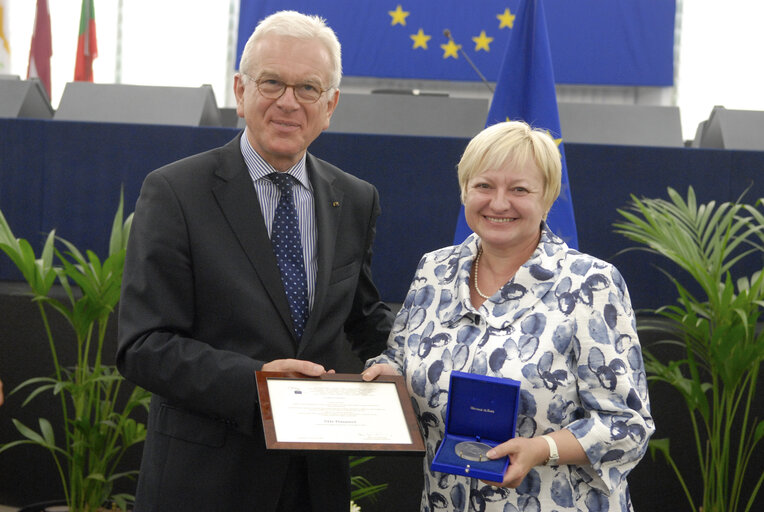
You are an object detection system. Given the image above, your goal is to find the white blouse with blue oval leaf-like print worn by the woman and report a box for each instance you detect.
[367,226,654,512]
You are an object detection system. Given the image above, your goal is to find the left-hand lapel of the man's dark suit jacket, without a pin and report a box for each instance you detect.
[212,137,292,331]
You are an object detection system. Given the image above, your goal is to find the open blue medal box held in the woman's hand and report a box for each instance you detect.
[430,371,520,482]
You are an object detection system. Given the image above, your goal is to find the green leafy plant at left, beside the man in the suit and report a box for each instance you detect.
[0,197,149,512]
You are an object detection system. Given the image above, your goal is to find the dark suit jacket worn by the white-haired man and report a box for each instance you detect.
[117,135,392,512]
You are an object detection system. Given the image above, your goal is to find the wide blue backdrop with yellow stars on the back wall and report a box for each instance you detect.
[237,0,676,86]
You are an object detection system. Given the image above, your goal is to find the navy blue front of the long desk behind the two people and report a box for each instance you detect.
[0,119,764,308]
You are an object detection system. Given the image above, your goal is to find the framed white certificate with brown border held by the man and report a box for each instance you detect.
[255,372,425,454]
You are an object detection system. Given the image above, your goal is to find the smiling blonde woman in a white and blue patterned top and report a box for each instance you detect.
[364,122,654,512]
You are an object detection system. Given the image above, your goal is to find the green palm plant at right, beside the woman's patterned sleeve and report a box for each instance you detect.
[615,187,764,512]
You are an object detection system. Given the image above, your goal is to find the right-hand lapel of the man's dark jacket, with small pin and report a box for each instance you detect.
[298,154,343,355]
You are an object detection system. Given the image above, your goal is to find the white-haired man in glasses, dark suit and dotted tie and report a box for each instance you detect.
[117,12,392,512]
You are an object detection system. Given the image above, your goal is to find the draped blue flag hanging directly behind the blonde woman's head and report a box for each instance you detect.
[454,0,578,249]
